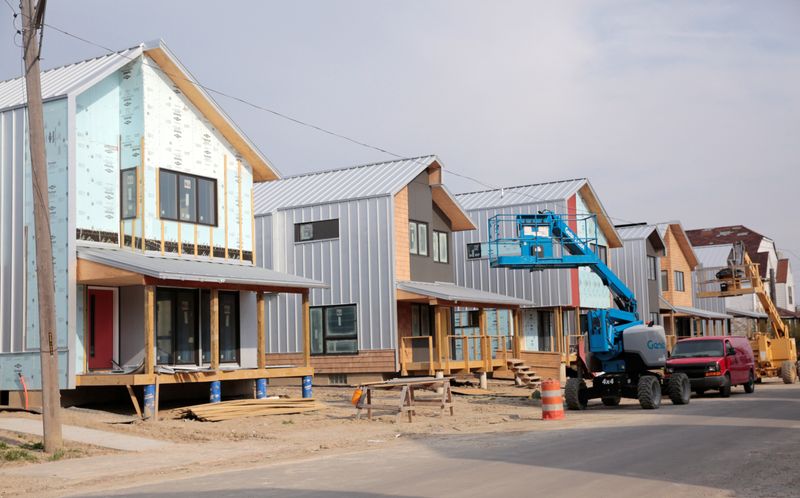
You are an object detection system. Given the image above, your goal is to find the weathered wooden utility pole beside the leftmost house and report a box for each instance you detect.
[20,0,63,453]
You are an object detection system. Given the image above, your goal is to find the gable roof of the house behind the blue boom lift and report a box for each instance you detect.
[456,178,622,248]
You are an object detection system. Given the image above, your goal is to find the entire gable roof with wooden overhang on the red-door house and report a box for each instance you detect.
[0,40,280,181]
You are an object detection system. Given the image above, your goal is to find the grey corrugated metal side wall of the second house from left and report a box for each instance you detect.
[256,196,397,353]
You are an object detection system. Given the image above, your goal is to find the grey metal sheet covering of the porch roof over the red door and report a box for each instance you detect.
[77,246,327,289]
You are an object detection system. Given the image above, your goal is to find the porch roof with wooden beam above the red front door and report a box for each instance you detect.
[77,246,327,292]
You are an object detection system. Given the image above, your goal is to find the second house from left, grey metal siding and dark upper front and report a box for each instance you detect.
[255,156,532,384]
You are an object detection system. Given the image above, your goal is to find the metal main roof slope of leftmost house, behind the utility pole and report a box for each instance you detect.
[0,46,142,109]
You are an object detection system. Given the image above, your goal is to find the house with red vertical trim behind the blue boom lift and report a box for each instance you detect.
[453,178,622,371]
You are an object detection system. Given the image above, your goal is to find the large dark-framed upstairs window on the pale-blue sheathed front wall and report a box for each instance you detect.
[158,169,217,226]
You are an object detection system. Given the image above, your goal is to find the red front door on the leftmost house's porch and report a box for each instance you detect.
[86,289,114,370]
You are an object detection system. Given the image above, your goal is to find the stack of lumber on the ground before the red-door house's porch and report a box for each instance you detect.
[175,398,322,422]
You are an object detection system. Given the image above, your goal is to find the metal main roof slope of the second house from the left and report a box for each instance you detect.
[254,155,439,215]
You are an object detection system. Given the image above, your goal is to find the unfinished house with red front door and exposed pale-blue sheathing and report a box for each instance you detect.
[0,42,323,403]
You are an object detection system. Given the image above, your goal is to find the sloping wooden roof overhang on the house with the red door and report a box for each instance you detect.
[143,40,280,182]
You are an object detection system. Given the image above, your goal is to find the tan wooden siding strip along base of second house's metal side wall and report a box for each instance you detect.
[267,349,397,374]
